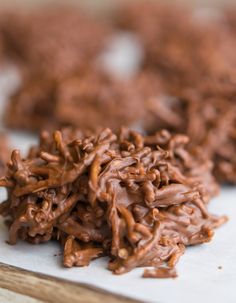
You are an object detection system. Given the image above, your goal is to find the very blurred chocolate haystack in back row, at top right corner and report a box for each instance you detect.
[116,1,236,88]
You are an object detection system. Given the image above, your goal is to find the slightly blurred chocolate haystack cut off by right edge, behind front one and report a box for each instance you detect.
[179,82,236,183]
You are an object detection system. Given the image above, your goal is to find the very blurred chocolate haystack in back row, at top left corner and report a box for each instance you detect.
[0,7,111,79]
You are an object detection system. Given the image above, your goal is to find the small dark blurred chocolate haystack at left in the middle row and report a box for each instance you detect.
[4,78,57,132]
